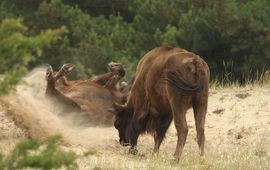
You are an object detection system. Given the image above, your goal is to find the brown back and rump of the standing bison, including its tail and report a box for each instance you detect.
[130,47,209,117]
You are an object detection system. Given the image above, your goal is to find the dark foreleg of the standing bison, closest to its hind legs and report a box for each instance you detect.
[154,115,172,153]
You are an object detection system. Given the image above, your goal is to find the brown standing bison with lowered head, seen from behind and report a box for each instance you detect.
[110,47,210,161]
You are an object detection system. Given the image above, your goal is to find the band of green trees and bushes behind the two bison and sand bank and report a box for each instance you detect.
[0,0,270,93]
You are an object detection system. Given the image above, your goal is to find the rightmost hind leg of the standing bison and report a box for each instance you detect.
[192,93,207,156]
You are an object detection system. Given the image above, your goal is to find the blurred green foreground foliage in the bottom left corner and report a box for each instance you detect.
[0,136,78,170]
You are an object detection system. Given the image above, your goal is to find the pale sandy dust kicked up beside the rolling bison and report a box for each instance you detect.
[1,67,117,147]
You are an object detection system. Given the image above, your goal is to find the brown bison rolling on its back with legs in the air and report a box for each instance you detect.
[45,63,125,125]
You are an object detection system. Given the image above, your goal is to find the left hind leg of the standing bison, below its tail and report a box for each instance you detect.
[170,97,188,162]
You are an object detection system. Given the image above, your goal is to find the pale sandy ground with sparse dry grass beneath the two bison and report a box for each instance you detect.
[0,68,270,170]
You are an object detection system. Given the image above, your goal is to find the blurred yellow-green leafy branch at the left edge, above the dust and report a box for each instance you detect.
[0,19,65,94]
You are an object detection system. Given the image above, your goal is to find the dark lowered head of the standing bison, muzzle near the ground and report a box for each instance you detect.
[109,104,131,146]
